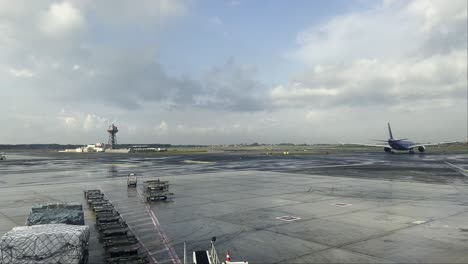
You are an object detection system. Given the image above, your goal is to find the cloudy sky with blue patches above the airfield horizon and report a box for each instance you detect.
[0,0,467,144]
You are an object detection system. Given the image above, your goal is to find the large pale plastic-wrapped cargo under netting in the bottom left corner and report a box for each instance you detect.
[0,224,89,264]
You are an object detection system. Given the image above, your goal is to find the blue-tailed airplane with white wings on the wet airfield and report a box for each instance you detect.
[359,123,452,154]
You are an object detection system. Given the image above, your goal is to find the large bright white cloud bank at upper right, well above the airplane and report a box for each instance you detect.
[276,1,467,109]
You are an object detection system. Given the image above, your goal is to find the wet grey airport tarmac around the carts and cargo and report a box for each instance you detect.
[0,152,468,263]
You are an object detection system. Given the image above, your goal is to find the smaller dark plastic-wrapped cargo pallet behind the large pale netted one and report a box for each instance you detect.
[26,203,84,225]
